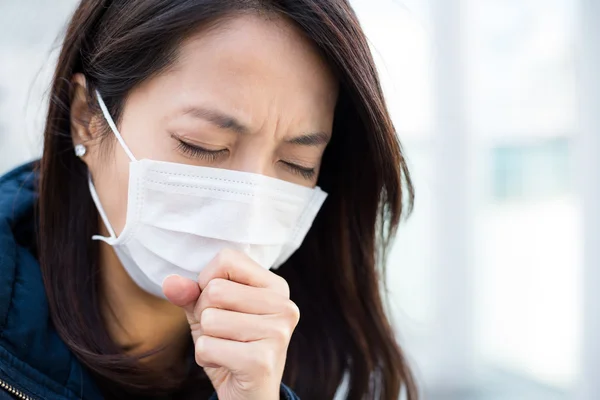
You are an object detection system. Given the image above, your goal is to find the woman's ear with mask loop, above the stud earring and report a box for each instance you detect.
[70,73,96,162]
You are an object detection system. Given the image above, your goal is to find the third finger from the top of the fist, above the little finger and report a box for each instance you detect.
[199,308,280,343]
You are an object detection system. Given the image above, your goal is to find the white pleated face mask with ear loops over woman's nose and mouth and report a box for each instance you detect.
[90,92,327,297]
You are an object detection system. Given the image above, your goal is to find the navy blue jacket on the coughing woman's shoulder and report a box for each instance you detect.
[0,164,298,400]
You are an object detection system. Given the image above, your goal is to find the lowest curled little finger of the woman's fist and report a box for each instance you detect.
[195,335,279,377]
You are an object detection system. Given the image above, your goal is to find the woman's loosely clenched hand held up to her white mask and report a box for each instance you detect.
[163,250,300,400]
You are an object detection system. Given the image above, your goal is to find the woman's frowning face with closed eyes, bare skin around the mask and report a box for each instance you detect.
[72,15,338,234]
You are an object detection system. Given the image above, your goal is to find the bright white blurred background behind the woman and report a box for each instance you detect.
[0,0,600,400]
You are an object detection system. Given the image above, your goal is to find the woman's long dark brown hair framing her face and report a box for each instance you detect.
[39,0,417,400]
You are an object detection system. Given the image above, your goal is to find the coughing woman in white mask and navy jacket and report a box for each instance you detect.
[0,0,416,400]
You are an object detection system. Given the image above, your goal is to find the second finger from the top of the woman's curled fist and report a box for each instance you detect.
[194,278,289,318]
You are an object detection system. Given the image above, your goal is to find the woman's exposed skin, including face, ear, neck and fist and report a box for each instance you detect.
[71,15,338,400]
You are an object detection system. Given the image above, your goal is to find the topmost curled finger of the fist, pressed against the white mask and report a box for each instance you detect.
[198,249,290,298]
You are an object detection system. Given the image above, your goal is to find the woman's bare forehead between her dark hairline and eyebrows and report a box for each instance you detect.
[135,14,338,123]
